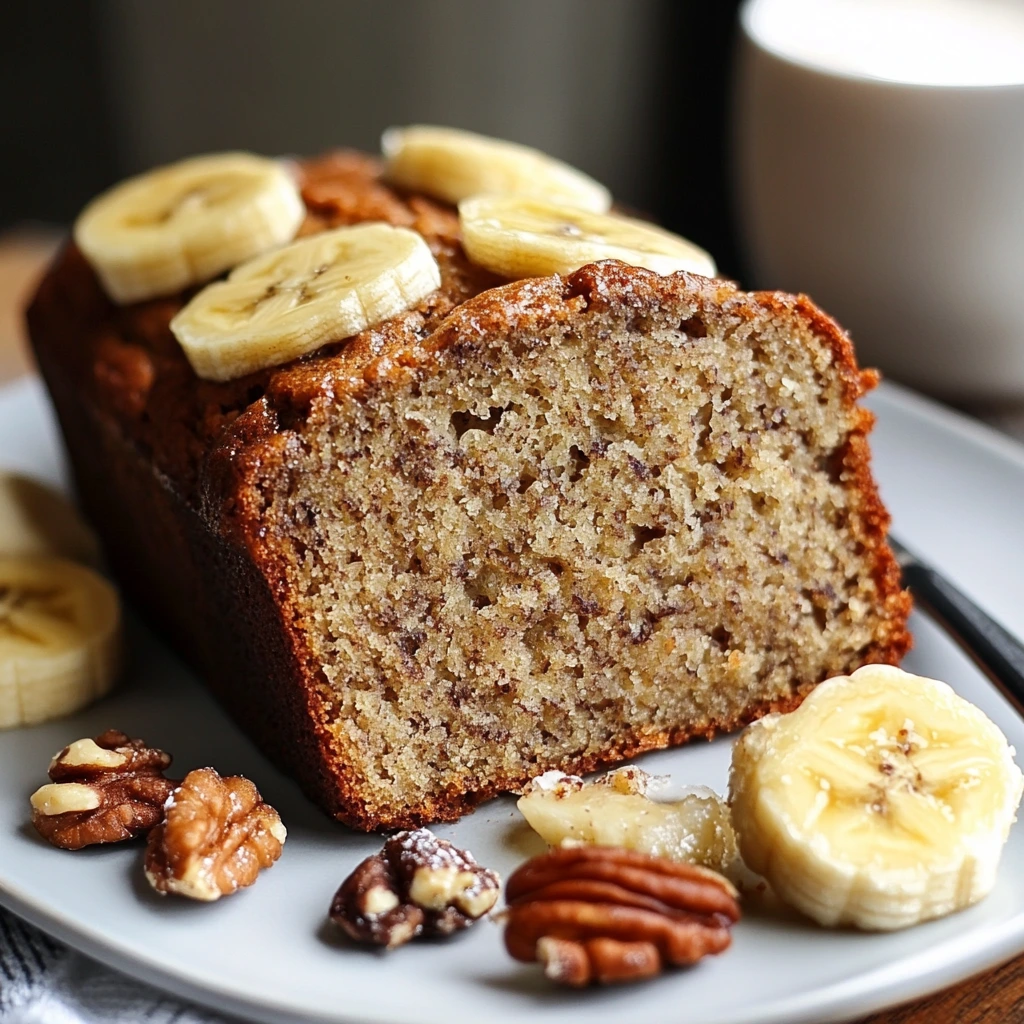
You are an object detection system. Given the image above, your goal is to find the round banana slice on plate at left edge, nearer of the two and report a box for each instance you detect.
[0,556,121,728]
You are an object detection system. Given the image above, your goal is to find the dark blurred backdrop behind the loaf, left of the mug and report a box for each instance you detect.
[0,0,738,273]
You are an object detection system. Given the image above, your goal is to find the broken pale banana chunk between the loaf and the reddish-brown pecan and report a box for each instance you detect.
[518,765,737,871]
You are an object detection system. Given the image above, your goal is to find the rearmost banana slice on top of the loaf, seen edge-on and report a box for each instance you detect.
[381,125,611,213]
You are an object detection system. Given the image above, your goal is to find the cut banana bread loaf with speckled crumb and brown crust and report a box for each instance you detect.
[29,155,909,828]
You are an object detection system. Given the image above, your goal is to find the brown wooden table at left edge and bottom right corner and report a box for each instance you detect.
[0,230,1024,1024]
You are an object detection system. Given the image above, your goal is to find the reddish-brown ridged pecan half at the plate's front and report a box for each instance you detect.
[505,847,739,986]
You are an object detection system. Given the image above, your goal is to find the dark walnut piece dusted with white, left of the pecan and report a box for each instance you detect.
[331,828,501,949]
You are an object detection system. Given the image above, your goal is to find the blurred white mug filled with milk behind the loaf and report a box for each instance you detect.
[734,0,1024,401]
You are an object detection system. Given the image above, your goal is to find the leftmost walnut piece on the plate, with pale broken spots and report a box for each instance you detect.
[31,729,177,850]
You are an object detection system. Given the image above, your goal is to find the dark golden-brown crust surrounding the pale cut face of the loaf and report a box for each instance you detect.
[29,154,910,829]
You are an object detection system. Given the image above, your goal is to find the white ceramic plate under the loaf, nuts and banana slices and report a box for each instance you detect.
[0,382,1024,1024]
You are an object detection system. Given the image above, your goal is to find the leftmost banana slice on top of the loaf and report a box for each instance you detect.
[74,153,305,303]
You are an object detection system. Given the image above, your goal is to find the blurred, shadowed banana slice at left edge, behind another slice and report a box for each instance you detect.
[0,472,99,563]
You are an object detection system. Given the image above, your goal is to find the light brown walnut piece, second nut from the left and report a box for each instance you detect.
[145,768,288,900]
